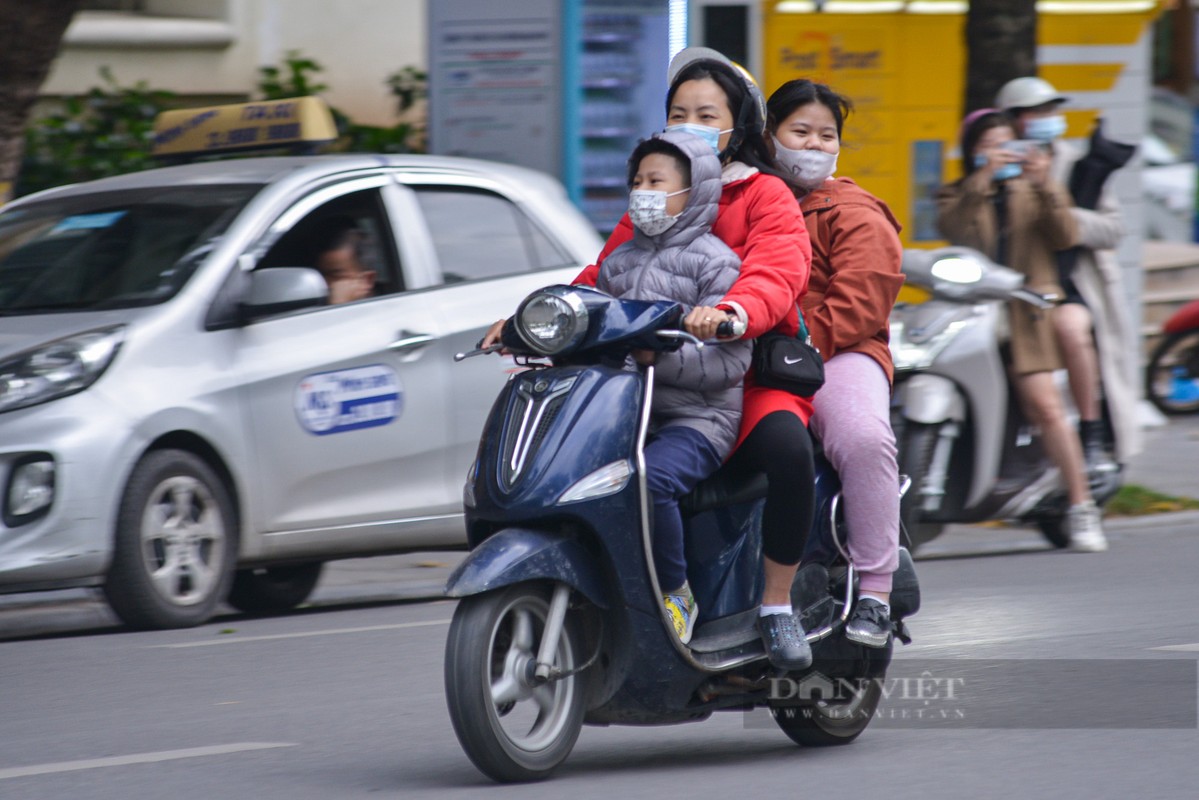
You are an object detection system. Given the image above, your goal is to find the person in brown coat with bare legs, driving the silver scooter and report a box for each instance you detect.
[936,109,1105,549]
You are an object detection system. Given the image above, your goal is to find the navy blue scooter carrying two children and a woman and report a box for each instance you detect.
[445,285,920,781]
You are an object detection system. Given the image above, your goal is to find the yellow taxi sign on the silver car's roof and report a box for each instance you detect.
[152,97,337,156]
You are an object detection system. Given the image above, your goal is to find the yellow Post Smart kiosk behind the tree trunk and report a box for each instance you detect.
[761,0,1159,247]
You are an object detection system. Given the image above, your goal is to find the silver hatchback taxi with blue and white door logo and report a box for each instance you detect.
[0,156,602,627]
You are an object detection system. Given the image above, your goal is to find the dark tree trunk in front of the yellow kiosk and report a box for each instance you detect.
[963,0,1037,116]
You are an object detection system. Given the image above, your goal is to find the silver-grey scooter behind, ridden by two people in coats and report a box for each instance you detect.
[891,247,1122,549]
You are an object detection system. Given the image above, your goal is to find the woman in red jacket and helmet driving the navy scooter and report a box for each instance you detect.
[482,47,814,668]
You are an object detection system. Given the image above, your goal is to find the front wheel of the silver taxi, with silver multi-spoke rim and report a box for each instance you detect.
[104,450,237,628]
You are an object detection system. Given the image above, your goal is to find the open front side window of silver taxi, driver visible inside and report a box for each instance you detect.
[255,188,404,305]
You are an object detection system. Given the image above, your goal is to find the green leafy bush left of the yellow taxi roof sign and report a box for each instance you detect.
[17,67,175,194]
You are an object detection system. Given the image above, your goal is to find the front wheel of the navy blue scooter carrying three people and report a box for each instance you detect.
[445,583,586,782]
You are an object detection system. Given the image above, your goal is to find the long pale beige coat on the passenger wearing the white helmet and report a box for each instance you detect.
[1052,142,1141,462]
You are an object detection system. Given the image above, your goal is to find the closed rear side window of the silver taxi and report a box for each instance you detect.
[412,186,573,283]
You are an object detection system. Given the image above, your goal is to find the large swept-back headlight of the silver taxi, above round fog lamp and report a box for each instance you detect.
[0,325,125,413]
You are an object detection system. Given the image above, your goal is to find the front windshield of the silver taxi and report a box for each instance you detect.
[0,185,261,315]
